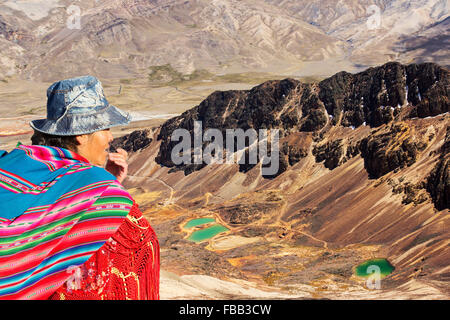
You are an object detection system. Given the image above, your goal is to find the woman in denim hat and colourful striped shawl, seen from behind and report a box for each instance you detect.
[0,76,159,299]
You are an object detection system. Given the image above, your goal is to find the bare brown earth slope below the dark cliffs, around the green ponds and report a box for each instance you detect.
[120,114,450,299]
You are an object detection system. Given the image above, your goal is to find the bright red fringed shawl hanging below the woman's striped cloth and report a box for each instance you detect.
[49,203,160,300]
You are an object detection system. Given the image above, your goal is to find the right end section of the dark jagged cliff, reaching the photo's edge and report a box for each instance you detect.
[319,62,450,127]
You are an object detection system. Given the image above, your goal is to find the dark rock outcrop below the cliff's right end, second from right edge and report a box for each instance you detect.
[360,123,418,179]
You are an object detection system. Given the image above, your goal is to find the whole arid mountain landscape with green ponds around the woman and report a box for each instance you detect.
[0,0,450,300]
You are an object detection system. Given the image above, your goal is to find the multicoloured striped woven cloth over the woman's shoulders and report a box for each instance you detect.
[0,145,133,299]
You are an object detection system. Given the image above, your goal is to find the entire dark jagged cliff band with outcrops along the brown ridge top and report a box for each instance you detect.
[156,62,449,177]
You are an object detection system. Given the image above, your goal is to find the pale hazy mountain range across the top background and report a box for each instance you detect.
[0,0,449,81]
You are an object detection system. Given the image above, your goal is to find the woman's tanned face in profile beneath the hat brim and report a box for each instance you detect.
[77,129,113,167]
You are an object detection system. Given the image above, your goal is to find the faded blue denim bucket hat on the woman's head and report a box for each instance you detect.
[30,76,131,136]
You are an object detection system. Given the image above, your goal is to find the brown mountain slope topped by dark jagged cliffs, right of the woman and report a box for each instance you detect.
[113,64,450,298]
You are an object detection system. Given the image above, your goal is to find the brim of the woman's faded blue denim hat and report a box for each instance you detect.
[30,105,131,136]
